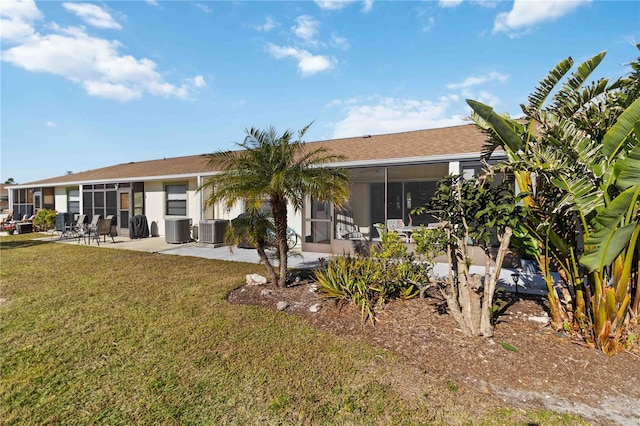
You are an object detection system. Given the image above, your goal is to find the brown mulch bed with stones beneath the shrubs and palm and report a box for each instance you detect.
[229,278,640,425]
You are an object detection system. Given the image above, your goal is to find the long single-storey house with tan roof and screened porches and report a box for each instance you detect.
[9,124,504,253]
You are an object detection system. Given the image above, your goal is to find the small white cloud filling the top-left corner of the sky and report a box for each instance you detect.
[0,0,43,43]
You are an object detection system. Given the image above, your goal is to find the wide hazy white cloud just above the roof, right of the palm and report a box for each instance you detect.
[329,97,468,138]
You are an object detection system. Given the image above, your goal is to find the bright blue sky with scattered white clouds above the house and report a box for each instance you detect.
[0,0,640,183]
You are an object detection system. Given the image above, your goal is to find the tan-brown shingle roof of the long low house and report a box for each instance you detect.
[23,124,486,186]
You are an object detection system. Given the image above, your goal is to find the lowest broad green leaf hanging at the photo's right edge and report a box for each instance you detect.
[580,187,640,272]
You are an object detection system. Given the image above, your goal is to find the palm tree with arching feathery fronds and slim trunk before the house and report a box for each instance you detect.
[199,124,349,287]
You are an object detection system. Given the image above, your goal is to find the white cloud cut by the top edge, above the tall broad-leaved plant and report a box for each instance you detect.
[493,0,591,33]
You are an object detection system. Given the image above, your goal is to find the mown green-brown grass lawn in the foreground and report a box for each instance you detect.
[0,235,576,425]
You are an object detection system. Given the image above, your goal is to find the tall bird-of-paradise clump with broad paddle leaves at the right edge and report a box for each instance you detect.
[467,45,640,354]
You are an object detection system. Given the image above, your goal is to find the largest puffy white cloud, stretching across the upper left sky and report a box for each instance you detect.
[0,2,206,101]
